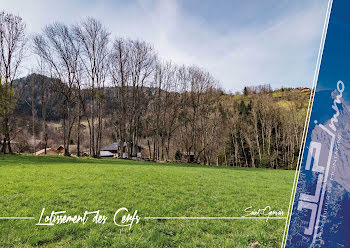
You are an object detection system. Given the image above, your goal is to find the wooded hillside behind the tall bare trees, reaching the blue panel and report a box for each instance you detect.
[10,74,310,169]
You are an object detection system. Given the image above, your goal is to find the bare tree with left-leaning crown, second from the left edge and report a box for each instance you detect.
[34,23,81,155]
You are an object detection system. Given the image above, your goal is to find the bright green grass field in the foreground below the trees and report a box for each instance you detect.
[0,155,294,247]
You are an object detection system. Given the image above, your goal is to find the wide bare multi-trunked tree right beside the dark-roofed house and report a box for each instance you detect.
[110,39,157,156]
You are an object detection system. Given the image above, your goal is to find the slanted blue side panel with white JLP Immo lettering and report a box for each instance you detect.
[285,0,350,248]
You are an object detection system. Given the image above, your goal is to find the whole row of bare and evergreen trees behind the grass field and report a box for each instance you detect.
[0,10,307,168]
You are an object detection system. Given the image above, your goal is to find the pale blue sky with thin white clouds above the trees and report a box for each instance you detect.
[0,0,328,92]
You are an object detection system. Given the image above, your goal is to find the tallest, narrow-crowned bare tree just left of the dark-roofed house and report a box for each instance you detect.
[74,18,110,157]
